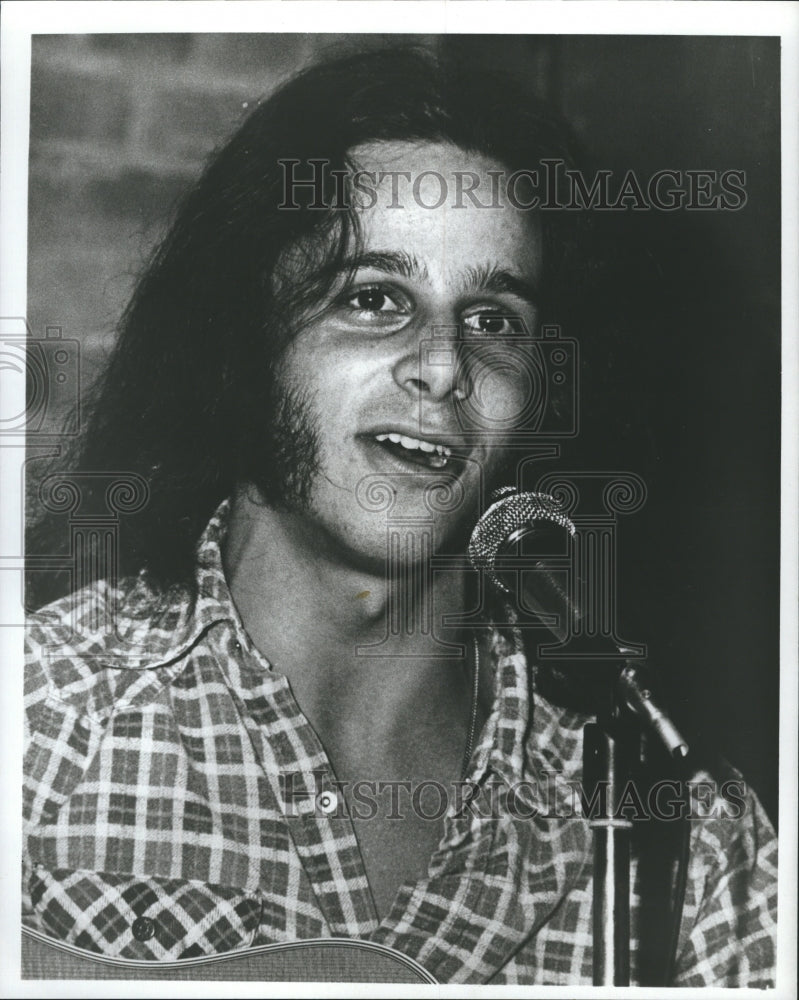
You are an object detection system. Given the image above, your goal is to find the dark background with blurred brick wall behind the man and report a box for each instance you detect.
[28,34,780,820]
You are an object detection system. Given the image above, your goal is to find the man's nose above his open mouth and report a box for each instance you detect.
[394,328,469,402]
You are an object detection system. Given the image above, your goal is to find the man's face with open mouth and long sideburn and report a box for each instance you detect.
[279,142,541,563]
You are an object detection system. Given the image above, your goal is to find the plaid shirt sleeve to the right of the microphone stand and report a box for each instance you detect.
[674,781,777,988]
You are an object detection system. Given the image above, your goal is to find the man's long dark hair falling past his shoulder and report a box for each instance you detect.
[28,48,574,604]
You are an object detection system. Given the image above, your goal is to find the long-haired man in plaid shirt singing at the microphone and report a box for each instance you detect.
[24,51,775,986]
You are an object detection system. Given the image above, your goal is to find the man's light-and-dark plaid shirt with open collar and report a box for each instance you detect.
[23,504,776,986]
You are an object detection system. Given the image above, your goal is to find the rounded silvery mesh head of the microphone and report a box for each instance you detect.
[469,486,575,591]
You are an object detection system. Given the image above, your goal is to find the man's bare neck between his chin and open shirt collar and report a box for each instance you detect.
[223,491,472,667]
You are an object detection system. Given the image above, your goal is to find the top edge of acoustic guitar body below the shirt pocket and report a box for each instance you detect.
[22,927,436,983]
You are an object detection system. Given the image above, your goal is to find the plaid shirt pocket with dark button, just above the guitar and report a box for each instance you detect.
[30,866,261,960]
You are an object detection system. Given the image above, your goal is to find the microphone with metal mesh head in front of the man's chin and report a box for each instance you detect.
[469,486,688,758]
